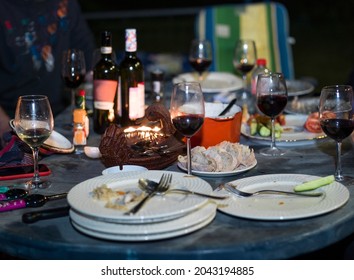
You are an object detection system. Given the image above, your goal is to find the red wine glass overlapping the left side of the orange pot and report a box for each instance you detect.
[170,82,205,175]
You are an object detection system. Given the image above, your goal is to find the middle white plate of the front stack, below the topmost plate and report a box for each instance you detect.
[70,203,216,237]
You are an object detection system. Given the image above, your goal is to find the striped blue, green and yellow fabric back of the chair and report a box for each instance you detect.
[196,2,294,79]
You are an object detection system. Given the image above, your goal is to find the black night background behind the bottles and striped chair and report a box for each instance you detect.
[79,0,354,90]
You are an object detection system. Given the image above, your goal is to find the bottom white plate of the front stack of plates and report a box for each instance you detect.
[72,211,216,241]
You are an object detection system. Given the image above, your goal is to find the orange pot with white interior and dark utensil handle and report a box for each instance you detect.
[191,103,242,148]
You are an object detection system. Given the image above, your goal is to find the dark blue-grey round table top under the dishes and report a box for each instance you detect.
[0,106,354,259]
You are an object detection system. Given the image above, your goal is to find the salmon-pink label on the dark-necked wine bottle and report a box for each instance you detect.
[93,80,118,110]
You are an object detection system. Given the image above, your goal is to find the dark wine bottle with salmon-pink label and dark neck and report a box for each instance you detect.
[93,31,119,134]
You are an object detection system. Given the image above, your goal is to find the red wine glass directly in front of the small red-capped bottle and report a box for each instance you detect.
[256,73,288,156]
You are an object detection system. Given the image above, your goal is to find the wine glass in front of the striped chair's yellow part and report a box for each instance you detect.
[233,40,257,100]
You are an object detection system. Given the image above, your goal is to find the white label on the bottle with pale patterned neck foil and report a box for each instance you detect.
[129,83,145,120]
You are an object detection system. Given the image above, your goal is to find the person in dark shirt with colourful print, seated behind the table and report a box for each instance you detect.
[0,0,95,145]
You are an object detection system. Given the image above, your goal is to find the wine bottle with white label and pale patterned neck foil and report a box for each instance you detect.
[119,29,145,127]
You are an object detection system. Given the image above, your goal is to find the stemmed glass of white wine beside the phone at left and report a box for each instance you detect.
[14,95,54,189]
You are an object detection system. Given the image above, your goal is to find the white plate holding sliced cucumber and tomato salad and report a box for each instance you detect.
[241,115,326,147]
